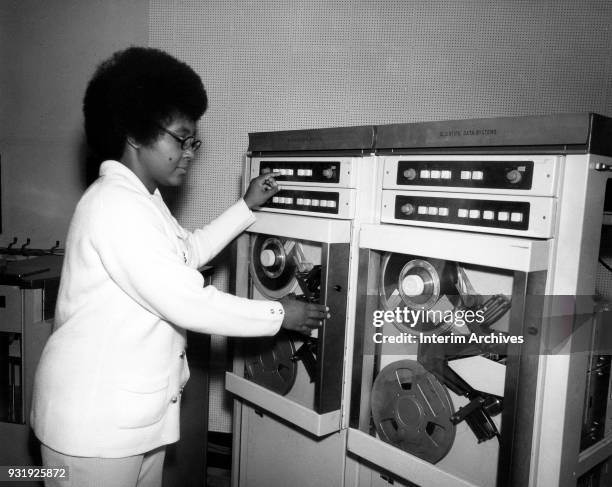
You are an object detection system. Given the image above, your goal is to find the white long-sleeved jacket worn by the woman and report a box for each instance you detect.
[31,161,283,458]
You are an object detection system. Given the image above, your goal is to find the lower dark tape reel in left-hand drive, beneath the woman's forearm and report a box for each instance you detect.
[245,330,298,396]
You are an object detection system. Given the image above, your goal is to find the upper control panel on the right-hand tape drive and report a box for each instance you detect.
[383,155,559,196]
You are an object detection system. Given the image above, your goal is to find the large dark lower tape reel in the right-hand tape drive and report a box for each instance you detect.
[371,360,455,463]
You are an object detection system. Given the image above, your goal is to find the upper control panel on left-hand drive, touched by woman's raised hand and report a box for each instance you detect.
[251,157,356,188]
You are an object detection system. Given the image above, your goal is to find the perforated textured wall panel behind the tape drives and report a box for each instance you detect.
[149,0,612,431]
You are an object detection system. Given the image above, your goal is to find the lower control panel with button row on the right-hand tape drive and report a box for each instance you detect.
[381,190,555,238]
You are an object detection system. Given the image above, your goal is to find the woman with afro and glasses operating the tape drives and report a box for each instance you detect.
[31,47,328,487]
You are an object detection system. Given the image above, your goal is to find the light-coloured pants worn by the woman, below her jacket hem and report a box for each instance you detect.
[41,445,166,487]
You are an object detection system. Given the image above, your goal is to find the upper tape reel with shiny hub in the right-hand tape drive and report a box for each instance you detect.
[379,253,457,333]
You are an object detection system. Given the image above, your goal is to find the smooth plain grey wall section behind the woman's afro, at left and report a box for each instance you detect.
[0,0,149,247]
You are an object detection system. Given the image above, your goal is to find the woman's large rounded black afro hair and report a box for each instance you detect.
[83,47,208,159]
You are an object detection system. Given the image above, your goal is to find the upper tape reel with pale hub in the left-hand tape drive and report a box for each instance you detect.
[249,235,297,299]
